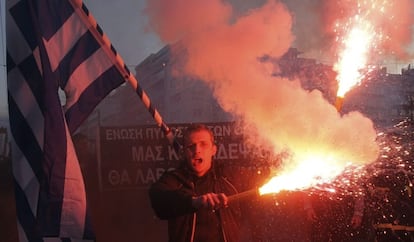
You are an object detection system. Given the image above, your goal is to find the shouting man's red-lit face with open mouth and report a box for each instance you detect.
[184,130,217,177]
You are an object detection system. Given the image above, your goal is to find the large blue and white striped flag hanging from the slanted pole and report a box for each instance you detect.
[6,0,129,241]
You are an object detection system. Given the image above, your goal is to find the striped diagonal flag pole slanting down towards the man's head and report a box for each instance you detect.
[70,0,180,151]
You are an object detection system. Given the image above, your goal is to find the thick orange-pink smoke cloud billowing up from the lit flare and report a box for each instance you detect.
[146,0,404,169]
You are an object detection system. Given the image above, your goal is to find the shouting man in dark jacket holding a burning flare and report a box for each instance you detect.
[149,124,266,242]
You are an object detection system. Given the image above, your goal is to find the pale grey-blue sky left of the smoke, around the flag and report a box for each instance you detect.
[0,0,163,117]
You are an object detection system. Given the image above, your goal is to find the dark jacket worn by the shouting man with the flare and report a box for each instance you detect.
[149,162,256,242]
